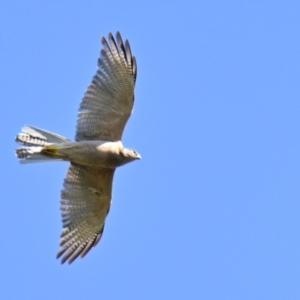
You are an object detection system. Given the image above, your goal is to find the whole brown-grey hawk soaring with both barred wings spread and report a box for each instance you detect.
[16,32,141,264]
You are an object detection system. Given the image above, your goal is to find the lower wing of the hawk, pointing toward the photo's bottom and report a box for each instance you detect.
[57,164,114,264]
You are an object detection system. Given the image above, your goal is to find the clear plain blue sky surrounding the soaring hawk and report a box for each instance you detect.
[0,0,300,300]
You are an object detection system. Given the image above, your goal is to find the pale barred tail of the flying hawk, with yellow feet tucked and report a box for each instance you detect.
[16,126,70,163]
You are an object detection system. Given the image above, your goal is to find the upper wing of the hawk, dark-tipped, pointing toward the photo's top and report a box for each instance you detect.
[75,32,137,141]
